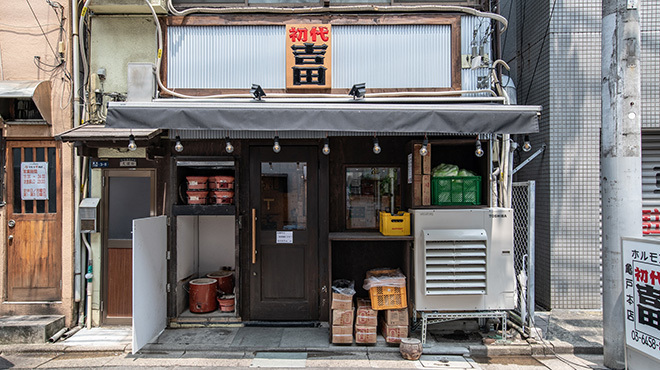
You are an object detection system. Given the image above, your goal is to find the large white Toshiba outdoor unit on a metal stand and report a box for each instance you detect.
[411,208,515,312]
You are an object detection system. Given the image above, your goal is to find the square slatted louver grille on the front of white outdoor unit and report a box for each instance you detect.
[423,230,488,295]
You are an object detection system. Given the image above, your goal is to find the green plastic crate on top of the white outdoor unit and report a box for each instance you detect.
[431,176,481,206]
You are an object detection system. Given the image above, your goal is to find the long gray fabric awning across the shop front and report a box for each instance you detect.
[106,99,541,137]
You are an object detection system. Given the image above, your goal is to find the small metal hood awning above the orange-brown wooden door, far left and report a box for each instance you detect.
[0,81,53,125]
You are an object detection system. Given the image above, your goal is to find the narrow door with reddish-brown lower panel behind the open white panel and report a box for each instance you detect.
[102,169,156,324]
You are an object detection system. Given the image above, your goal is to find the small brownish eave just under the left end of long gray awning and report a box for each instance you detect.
[55,124,162,142]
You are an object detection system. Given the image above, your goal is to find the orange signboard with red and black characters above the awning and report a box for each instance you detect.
[286,24,332,89]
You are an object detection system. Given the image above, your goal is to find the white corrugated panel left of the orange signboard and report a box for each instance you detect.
[167,26,285,89]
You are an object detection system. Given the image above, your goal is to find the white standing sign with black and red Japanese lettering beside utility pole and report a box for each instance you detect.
[623,239,660,359]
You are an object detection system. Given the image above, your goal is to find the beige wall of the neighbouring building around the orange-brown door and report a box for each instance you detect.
[0,0,74,326]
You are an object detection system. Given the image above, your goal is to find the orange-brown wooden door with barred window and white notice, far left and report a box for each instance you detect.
[6,141,62,302]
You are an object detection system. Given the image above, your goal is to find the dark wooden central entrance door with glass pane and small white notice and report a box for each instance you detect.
[249,147,319,321]
